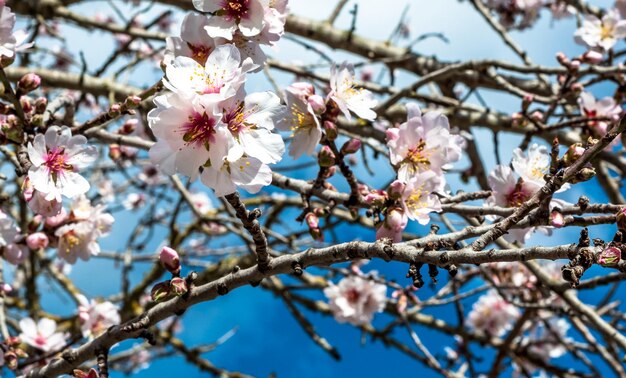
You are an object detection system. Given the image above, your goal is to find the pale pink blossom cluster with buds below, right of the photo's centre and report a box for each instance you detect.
[365,104,465,242]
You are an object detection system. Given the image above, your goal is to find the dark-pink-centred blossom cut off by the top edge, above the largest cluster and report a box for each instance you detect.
[193,0,265,40]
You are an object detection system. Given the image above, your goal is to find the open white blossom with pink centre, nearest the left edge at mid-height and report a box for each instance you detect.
[28,126,97,202]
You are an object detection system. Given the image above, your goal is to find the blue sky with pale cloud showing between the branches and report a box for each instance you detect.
[9,0,614,378]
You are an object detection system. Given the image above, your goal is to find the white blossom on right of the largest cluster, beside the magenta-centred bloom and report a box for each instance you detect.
[220,92,285,164]
